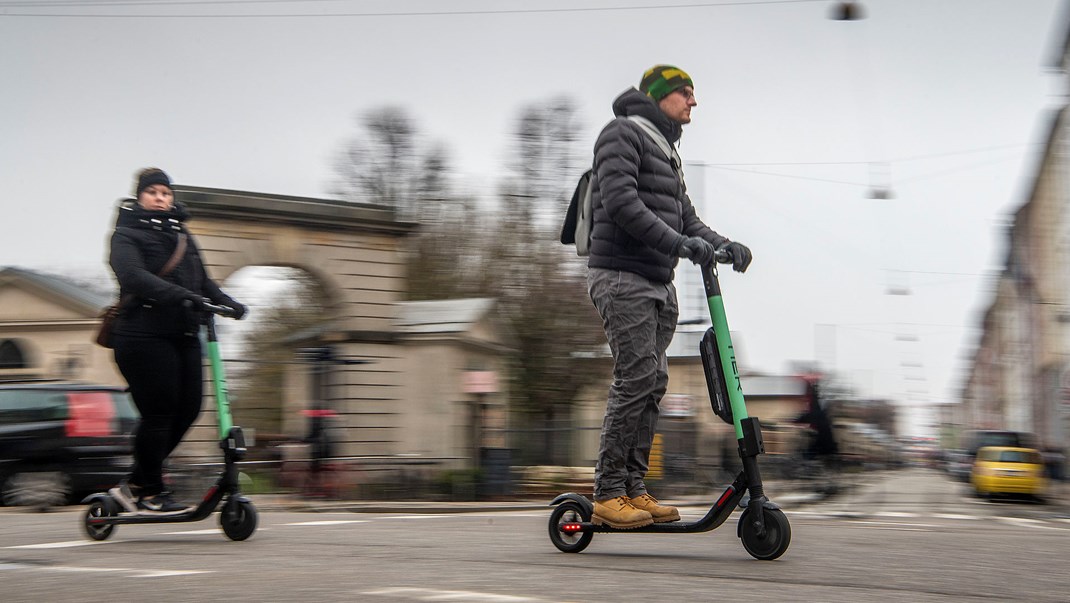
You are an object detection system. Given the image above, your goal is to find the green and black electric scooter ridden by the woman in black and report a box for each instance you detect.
[82,304,257,540]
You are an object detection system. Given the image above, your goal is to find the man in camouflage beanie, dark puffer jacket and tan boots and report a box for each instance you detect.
[587,65,751,528]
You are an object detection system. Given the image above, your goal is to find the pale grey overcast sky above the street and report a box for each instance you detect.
[0,0,1066,430]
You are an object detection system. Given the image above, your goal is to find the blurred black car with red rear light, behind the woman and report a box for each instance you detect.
[0,383,138,507]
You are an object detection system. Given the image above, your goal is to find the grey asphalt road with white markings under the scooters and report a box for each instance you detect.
[0,469,1070,603]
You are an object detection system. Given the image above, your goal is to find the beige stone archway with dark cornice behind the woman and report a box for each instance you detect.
[174,186,416,455]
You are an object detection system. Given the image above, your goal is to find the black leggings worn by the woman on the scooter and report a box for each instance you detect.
[114,336,203,496]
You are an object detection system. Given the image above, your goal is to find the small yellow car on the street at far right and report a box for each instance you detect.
[969,446,1045,496]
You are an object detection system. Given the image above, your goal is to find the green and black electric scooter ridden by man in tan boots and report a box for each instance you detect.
[549,251,792,560]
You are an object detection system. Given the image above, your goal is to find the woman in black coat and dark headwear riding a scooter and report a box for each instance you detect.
[110,168,245,513]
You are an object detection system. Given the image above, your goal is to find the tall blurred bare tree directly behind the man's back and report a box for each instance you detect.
[489,99,608,463]
